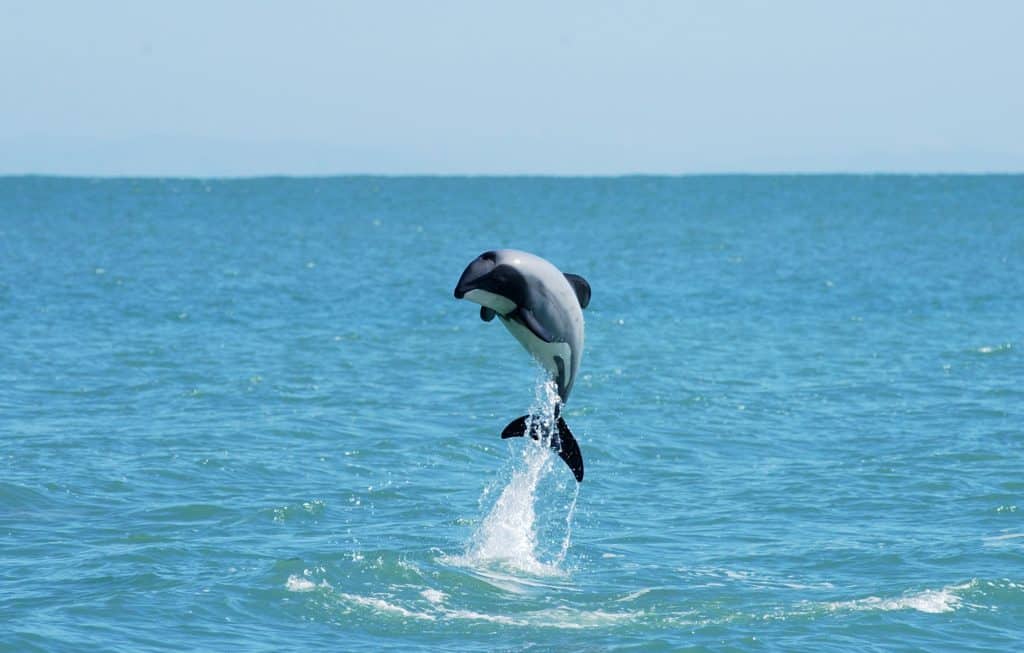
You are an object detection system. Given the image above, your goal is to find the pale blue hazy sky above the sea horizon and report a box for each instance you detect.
[0,0,1024,176]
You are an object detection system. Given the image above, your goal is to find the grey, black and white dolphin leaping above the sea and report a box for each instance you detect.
[455,250,590,482]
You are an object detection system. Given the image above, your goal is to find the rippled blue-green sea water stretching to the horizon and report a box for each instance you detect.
[0,176,1024,652]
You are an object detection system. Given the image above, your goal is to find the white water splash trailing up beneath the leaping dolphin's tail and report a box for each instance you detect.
[455,378,580,576]
